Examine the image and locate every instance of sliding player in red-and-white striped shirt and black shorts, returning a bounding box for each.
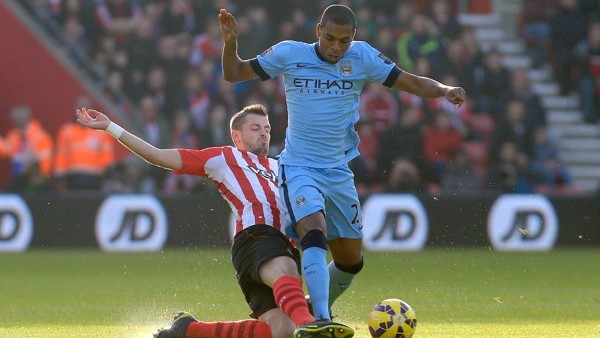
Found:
[76,104,354,338]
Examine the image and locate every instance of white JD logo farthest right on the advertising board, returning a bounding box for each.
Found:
[488,195,558,251]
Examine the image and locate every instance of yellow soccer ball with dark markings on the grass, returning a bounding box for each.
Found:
[369,299,417,338]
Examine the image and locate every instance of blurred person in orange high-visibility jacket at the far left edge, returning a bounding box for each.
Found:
[0,105,54,184]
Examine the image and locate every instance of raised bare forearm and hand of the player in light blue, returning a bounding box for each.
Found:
[219,9,258,82]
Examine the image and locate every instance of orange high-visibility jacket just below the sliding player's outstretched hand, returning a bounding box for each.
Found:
[54,123,115,176]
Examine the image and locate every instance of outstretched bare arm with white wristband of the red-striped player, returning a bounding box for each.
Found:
[75,108,183,169]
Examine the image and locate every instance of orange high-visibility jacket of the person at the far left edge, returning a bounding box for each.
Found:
[0,119,54,176]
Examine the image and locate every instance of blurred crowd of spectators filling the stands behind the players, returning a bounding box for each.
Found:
[0,0,600,196]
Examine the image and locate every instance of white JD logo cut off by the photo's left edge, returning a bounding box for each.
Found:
[0,195,33,251]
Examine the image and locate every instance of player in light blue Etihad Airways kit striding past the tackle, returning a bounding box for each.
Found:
[219,5,466,337]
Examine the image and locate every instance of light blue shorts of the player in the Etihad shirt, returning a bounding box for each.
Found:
[279,164,363,240]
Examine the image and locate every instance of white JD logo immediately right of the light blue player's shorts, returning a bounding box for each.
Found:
[363,194,429,251]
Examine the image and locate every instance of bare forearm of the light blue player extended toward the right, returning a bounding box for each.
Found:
[394,72,466,107]
